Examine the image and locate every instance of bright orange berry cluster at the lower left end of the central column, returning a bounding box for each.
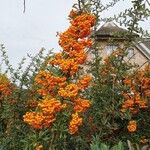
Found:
[23,98,66,129]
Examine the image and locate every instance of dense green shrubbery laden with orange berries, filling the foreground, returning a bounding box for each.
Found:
[0,0,150,150]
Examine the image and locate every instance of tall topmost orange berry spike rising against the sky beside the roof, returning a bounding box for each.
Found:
[49,10,95,76]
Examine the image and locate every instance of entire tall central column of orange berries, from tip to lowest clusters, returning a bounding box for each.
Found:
[24,10,95,134]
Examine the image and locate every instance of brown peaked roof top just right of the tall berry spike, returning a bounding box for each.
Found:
[95,21,138,39]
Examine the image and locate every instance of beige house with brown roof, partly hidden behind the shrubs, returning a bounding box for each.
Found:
[95,22,150,67]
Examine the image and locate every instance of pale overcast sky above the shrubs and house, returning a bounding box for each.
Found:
[0,0,149,67]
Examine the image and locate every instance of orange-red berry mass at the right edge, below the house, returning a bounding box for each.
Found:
[122,66,150,114]
